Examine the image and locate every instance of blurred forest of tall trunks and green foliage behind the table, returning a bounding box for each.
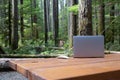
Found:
[0,0,120,55]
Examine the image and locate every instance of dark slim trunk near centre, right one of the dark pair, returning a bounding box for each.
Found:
[53,0,59,46]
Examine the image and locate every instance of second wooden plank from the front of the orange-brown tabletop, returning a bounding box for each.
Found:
[9,54,120,70]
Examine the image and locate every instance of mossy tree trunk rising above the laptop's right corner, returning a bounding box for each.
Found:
[98,0,105,36]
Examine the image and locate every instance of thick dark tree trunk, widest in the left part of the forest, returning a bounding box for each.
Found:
[11,0,18,50]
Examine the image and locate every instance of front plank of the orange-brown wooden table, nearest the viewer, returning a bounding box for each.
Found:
[29,61,120,80]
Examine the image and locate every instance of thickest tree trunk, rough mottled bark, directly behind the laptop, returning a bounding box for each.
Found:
[79,0,93,35]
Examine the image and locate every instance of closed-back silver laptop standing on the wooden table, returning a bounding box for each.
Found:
[73,36,104,57]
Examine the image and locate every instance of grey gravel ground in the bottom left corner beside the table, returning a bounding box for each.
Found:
[0,71,28,80]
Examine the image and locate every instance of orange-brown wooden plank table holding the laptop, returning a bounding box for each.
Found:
[8,54,120,80]
